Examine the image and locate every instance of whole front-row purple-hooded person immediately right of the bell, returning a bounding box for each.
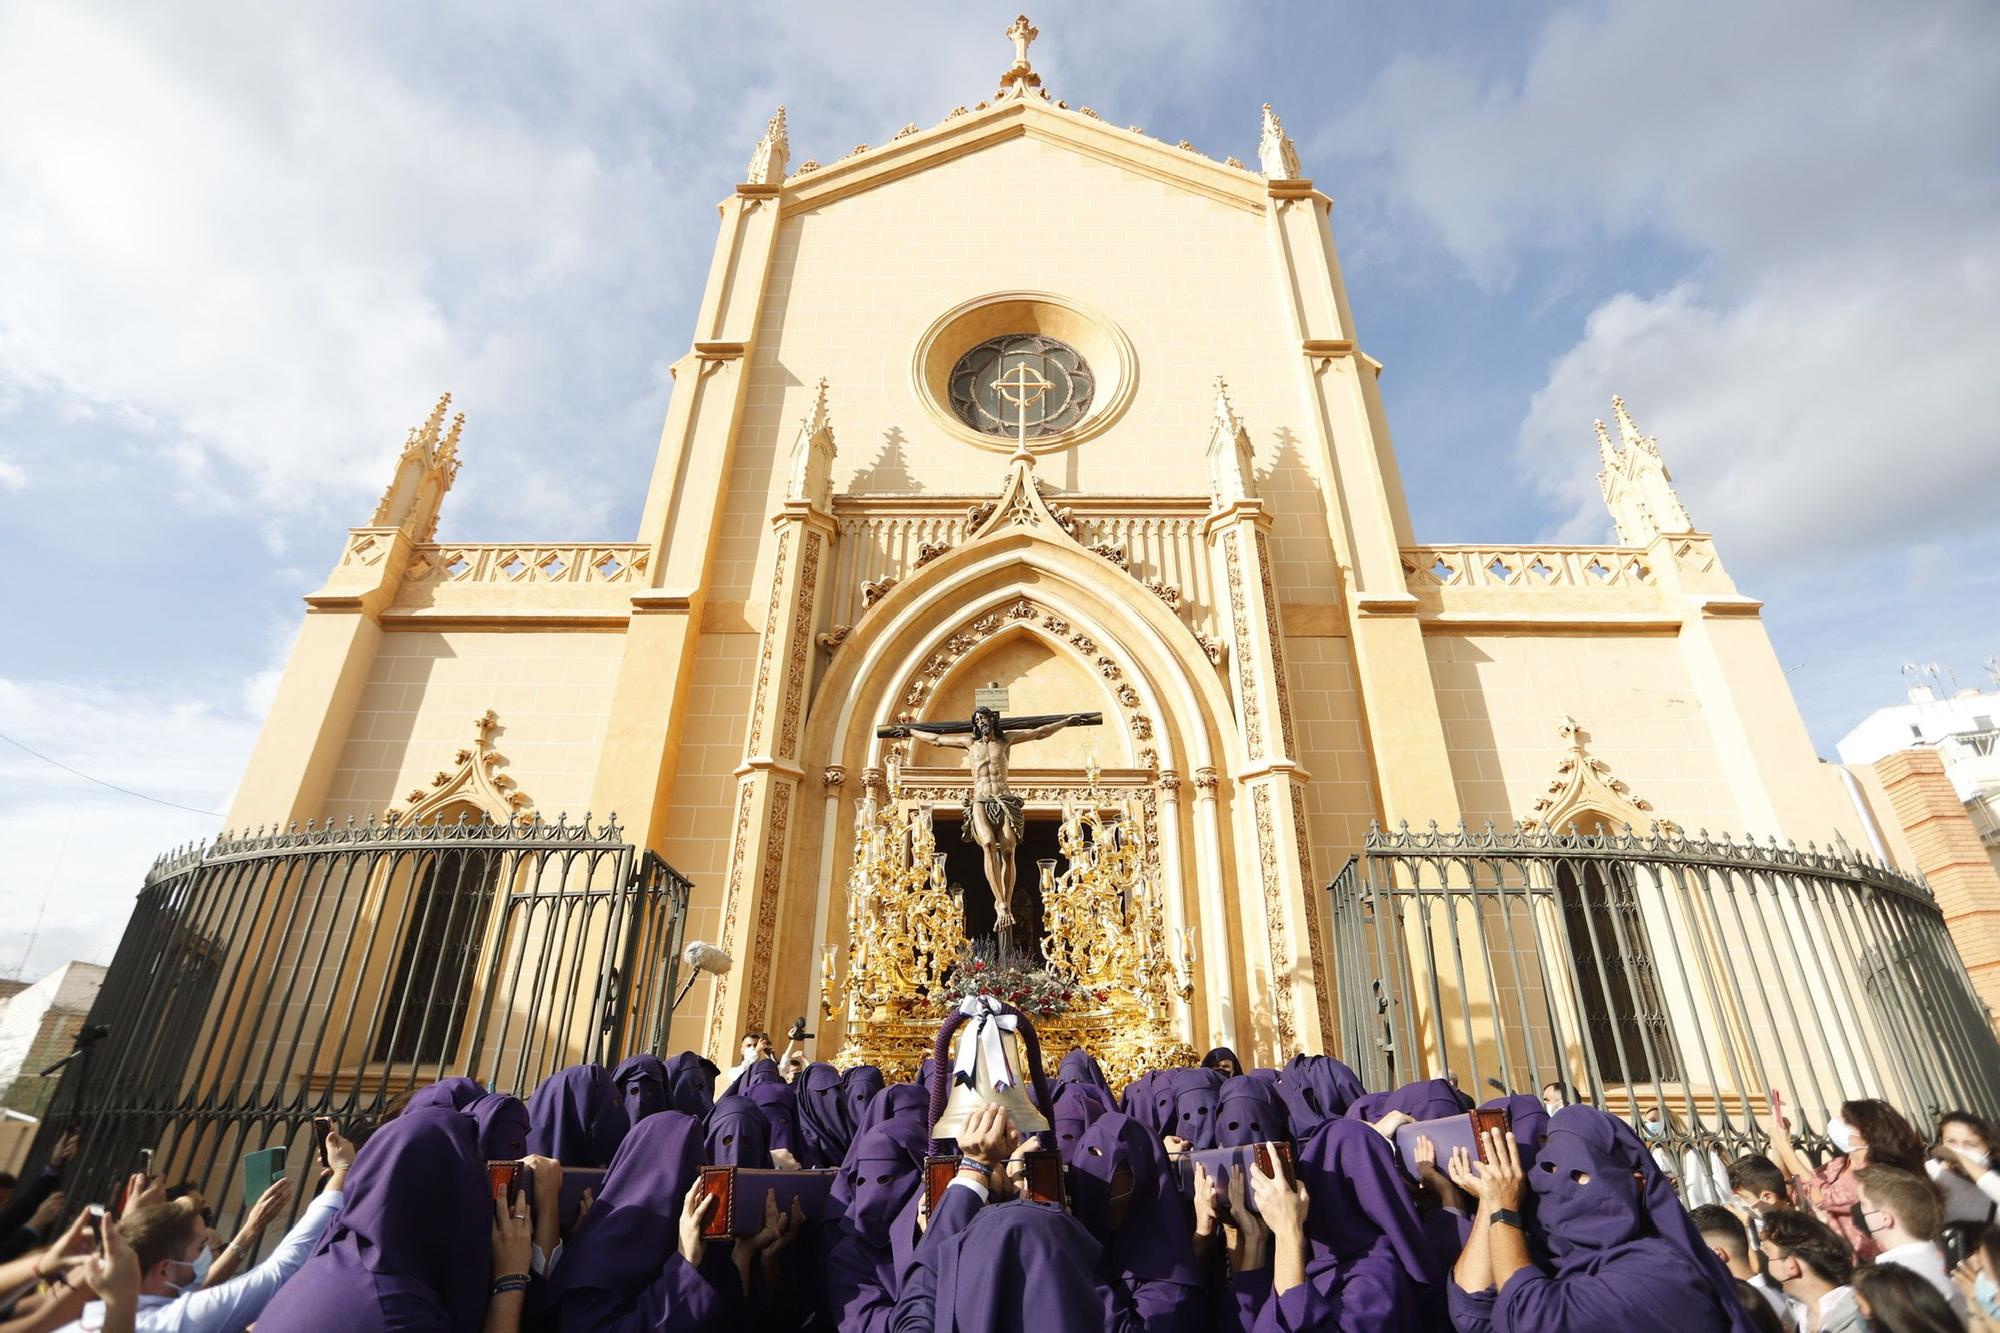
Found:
[1070,1113,1208,1333]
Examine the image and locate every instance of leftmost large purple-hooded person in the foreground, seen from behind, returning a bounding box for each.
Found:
[258,1107,492,1333]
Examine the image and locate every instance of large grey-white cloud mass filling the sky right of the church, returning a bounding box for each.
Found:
[1342,0,2000,572]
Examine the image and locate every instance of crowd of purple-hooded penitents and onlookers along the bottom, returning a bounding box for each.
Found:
[0,1016,2000,1333]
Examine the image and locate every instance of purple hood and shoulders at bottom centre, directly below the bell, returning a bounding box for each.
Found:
[894,1189,1142,1333]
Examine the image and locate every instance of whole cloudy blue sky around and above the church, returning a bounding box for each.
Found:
[0,0,2000,977]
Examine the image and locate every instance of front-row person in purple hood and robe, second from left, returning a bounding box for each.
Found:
[548,1111,744,1333]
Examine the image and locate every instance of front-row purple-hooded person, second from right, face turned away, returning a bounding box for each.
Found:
[1236,1119,1446,1333]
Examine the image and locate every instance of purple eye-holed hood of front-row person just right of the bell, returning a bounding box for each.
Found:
[1058,1105,1202,1289]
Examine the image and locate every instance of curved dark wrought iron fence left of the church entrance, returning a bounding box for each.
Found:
[30,821,690,1213]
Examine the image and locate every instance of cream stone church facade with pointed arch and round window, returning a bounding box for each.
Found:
[232,31,1896,1063]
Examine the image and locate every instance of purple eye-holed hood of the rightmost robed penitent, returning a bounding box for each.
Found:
[1528,1107,1752,1333]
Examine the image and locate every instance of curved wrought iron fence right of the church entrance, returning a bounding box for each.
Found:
[1330,829,2000,1157]
